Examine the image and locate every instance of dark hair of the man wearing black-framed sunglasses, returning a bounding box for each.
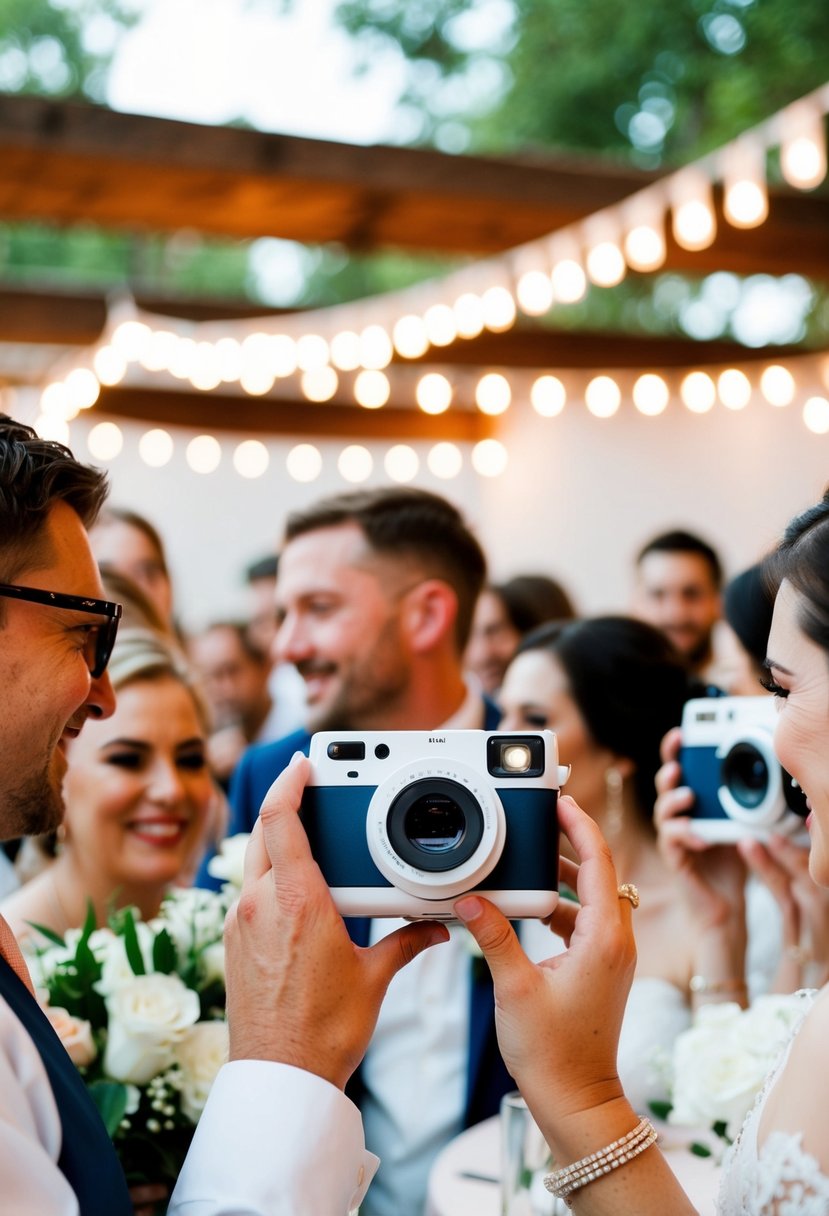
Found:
[0,413,108,582]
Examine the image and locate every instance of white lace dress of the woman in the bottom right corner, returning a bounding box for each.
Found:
[717,992,829,1216]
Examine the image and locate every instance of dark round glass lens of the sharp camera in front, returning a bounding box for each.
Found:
[387,777,484,873]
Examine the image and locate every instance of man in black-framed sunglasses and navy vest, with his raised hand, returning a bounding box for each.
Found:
[0,416,446,1216]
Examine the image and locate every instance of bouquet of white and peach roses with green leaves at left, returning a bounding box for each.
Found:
[29,844,249,1190]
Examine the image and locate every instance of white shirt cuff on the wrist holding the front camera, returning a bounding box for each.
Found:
[169,1060,379,1216]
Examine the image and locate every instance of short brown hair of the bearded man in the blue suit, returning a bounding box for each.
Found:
[284,486,486,651]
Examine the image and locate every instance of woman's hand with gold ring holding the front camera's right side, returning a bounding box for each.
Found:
[455,796,636,1132]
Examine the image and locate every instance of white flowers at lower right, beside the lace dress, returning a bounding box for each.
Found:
[654,992,810,1156]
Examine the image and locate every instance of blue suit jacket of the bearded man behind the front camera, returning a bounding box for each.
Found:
[198,699,515,1127]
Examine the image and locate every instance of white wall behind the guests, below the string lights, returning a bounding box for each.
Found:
[16,401,829,627]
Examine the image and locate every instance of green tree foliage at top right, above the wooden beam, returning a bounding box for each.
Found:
[337,0,829,168]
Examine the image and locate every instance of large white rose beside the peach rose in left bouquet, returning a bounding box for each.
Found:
[103,975,199,1085]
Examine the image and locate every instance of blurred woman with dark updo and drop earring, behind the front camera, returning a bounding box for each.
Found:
[500,617,707,1109]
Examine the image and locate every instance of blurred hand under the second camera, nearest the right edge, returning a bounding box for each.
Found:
[738,835,829,992]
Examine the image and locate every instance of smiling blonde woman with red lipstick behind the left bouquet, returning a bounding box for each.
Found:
[2,629,218,936]
